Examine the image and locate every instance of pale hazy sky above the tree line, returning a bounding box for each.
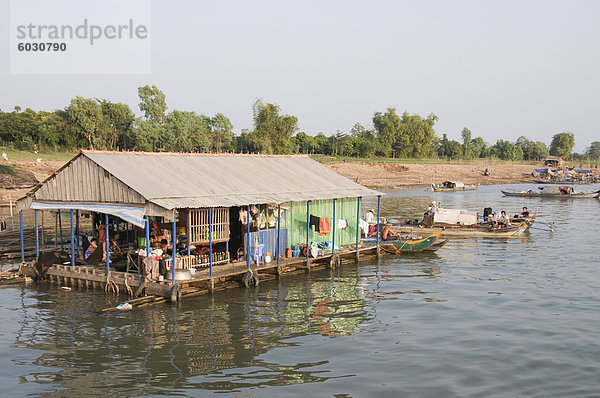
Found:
[0,0,600,152]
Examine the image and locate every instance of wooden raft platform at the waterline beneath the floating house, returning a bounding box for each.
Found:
[20,246,377,311]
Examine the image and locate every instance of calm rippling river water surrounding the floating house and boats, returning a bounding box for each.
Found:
[0,185,600,397]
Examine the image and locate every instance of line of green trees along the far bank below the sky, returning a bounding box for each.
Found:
[0,86,600,161]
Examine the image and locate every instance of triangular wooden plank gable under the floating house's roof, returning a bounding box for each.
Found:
[34,156,146,204]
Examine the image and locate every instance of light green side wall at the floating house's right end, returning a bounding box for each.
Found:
[287,198,357,246]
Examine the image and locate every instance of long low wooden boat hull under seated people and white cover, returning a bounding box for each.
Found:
[392,221,530,237]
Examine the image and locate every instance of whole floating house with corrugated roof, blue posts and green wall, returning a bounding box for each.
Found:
[17,150,381,304]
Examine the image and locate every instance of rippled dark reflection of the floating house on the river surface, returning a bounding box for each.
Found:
[7,268,366,395]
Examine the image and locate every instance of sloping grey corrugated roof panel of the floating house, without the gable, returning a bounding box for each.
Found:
[82,151,381,209]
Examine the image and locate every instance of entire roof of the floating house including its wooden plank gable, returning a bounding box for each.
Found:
[20,151,381,222]
